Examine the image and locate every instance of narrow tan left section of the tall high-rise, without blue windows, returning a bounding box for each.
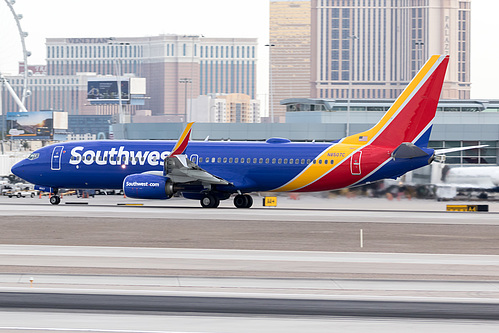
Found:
[269,0,311,122]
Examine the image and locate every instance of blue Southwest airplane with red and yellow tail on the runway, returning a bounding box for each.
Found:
[12,55,484,208]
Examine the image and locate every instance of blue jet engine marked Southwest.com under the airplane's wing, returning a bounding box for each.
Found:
[123,173,175,199]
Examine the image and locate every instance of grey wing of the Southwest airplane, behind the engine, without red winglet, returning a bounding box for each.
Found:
[164,155,230,185]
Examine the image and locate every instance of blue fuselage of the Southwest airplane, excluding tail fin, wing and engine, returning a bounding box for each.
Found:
[12,140,433,193]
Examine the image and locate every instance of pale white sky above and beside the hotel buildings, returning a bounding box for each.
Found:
[0,0,499,105]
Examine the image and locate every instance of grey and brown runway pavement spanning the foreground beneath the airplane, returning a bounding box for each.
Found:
[0,197,499,332]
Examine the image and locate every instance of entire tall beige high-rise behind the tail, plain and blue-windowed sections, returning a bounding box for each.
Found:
[270,0,471,122]
